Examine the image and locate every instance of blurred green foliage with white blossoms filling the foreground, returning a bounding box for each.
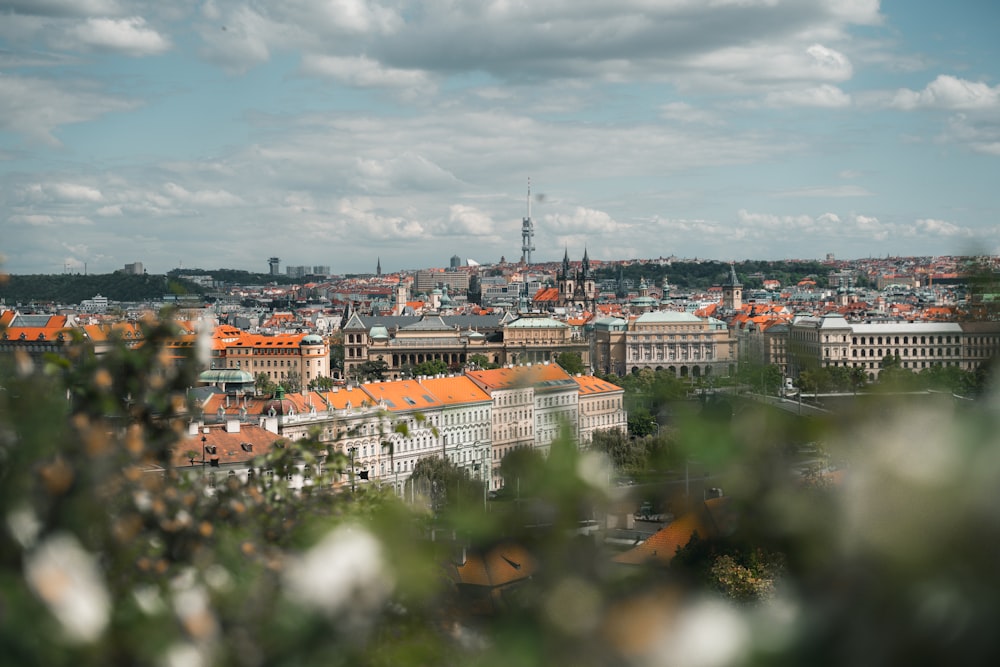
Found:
[0,314,1000,667]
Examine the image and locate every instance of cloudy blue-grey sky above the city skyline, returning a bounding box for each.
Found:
[0,0,1000,274]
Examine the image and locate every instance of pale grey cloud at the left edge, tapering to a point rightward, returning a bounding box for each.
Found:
[0,73,138,145]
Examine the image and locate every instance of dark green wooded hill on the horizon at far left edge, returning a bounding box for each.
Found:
[0,273,204,306]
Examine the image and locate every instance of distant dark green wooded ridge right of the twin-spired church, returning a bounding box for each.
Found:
[595,260,867,289]
